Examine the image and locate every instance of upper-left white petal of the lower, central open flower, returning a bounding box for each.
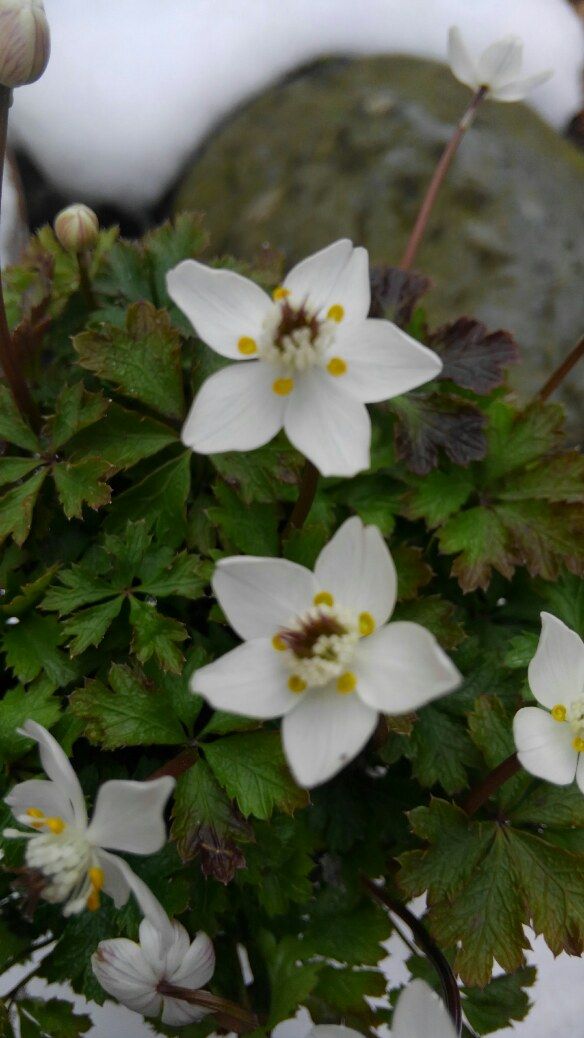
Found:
[213,555,316,638]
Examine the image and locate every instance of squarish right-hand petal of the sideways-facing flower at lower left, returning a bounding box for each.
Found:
[87,775,174,854]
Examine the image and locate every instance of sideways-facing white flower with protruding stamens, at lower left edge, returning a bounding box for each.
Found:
[4,720,174,916]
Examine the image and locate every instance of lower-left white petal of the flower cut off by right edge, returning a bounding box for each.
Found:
[513,707,578,786]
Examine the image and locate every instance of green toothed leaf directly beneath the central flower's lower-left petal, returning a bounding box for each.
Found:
[204,732,308,819]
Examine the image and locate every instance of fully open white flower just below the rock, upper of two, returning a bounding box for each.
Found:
[167,240,442,476]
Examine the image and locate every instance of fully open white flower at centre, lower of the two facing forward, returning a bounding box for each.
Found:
[191,517,460,787]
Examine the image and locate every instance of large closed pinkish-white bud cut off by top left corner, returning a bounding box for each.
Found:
[0,0,51,88]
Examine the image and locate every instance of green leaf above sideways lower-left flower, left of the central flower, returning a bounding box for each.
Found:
[69,663,185,749]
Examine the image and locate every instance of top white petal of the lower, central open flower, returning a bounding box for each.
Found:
[314,516,397,627]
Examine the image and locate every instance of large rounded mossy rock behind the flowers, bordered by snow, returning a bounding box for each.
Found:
[175,57,584,421]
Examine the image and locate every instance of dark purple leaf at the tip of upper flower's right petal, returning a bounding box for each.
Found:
[427,318,519,393]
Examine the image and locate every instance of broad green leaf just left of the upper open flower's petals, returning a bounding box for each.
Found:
[74,302,185,418]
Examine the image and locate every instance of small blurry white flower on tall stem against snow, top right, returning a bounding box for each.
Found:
[448,26,553,101]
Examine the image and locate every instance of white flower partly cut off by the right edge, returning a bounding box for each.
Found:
[513,612,584,793]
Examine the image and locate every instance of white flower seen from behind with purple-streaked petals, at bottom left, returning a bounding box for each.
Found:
[91,889,215,1028]
